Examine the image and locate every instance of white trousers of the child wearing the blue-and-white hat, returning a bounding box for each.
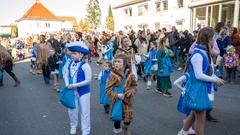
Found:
[68,93,91,135]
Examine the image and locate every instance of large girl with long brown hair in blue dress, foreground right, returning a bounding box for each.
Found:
[178,27,224,135]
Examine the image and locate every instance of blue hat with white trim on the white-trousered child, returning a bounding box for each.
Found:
[66,41,90,55]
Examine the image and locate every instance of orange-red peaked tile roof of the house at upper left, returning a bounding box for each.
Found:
[17,0,60,21]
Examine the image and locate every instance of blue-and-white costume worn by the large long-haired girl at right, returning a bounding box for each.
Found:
[183,45,217,111]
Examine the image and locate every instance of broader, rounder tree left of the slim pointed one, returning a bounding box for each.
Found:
[86,0,101,30]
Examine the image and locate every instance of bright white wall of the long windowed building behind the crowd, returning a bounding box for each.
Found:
[113,0,190,31]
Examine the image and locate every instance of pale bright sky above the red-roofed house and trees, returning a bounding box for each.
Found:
[0,0,127,25]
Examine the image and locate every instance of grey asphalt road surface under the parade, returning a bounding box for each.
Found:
[0,59,240,135]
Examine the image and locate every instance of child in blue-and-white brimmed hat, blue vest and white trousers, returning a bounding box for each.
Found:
[64,41,92,135]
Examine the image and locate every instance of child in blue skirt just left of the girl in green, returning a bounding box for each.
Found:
[144,41,158,90]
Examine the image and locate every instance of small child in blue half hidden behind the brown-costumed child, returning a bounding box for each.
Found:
[98,62,112,114]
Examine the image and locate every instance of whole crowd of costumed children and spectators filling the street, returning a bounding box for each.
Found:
[0,22,240,135]
